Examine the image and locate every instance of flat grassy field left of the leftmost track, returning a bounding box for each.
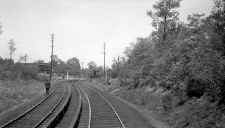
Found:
[0,80,44,113]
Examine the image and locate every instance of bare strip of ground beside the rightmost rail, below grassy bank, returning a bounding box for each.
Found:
[91,87,155,128]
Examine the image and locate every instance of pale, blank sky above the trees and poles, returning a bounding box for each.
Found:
[0,0,213,66]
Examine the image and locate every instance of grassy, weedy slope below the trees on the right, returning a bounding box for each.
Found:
[90,78,225,128]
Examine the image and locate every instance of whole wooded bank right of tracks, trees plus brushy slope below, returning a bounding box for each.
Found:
[111,0,225,128]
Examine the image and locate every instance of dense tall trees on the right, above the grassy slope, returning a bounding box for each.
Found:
[111,0,225,103]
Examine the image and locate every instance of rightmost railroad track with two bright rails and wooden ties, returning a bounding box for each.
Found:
[80,86,125,128]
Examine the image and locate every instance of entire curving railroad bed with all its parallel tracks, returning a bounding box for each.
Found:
[0,82,154,128]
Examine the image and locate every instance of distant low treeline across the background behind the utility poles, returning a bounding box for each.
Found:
[0,36,104,80]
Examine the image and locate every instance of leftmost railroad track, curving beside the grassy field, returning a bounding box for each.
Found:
[1,86,68,128]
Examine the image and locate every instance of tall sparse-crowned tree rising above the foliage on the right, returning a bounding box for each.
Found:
[147,0,181,40]
